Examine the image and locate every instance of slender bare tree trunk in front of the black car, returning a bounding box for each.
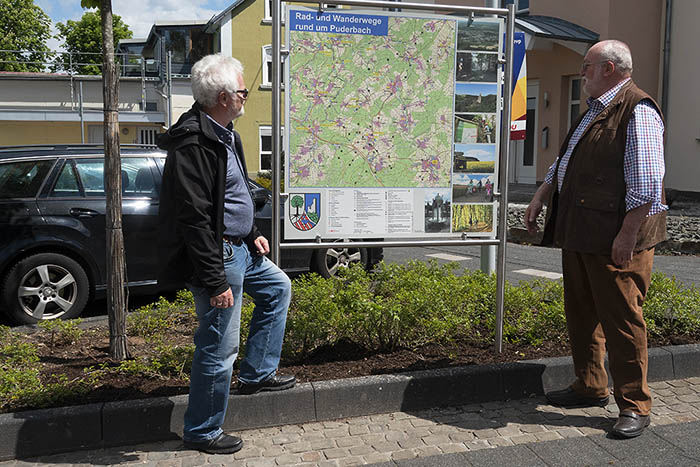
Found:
[100,0,129,361]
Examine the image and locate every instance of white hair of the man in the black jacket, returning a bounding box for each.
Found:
[191,54,243,107]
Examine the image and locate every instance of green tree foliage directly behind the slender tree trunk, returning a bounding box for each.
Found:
[55,10,133,75]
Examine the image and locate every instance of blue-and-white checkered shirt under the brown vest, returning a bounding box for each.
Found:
[544,78,668,216]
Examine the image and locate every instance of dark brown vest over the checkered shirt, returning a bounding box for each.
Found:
[542,80,666,256]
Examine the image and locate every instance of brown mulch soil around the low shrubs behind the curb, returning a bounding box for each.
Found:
[6,326,694,412]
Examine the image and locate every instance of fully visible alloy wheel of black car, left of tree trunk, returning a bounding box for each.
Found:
[2,253,90,324]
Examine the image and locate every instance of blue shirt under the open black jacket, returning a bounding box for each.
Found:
[207,115,255,237]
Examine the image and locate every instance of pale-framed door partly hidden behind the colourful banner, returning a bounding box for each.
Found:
[508,82,540,184]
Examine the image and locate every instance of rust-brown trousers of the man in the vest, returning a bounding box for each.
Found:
[562,248,654,415]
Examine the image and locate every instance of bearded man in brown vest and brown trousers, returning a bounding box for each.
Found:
[525,40,667,438]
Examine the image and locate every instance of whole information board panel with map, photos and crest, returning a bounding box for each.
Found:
[284,7,503,239]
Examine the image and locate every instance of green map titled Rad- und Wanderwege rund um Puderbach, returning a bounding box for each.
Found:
[287,9,457,188]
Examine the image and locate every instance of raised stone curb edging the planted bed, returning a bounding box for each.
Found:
[0,344,700,460]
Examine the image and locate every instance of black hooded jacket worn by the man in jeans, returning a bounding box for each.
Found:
[158,103,260,297]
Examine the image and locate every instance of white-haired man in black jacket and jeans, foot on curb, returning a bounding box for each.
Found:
[158,54,296,454]
